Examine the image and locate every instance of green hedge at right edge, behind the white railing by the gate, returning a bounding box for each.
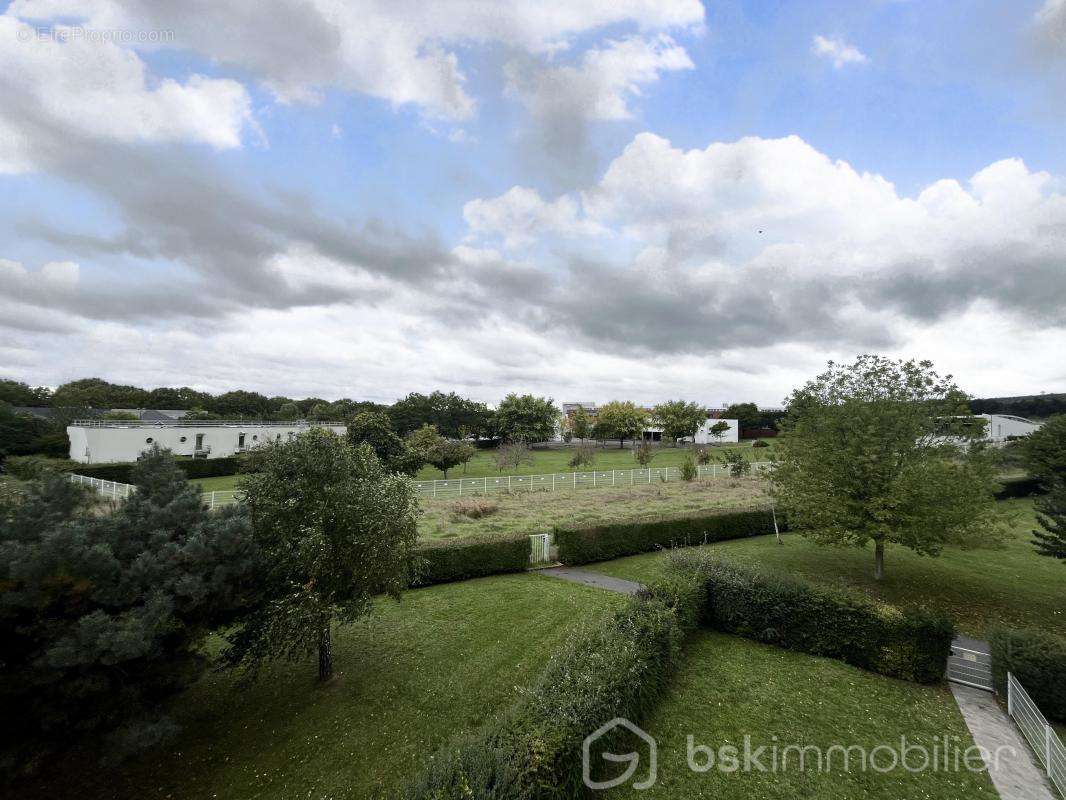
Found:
[988,628,1066,722]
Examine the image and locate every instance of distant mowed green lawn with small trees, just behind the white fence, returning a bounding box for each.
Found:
[194,439,773,492]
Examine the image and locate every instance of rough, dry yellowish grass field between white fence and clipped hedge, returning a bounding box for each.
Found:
[418,478,765,539]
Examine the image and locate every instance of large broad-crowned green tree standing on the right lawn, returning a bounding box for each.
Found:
[776,355,1002,580]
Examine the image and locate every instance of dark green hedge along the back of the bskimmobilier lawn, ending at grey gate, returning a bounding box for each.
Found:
[671,551,955,684]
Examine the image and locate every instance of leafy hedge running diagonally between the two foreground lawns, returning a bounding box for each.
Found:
[403,596,683,800]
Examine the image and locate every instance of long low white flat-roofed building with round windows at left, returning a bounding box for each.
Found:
[67,419,348,464]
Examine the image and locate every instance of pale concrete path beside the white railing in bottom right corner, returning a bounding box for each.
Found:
[949,684,1056,800]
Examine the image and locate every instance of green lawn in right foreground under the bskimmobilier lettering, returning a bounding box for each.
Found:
[607,633,998,800]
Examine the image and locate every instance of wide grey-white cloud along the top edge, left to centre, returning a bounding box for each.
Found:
[9,0,704,119]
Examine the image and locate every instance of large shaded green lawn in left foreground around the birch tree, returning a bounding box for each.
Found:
[13,574,623,800]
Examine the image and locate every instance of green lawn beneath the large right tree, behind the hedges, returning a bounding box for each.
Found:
[589,499,1066,637]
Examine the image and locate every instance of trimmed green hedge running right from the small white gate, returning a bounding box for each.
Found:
[554,509,781,564]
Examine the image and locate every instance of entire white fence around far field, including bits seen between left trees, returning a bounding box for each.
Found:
[69,461,773,509]
